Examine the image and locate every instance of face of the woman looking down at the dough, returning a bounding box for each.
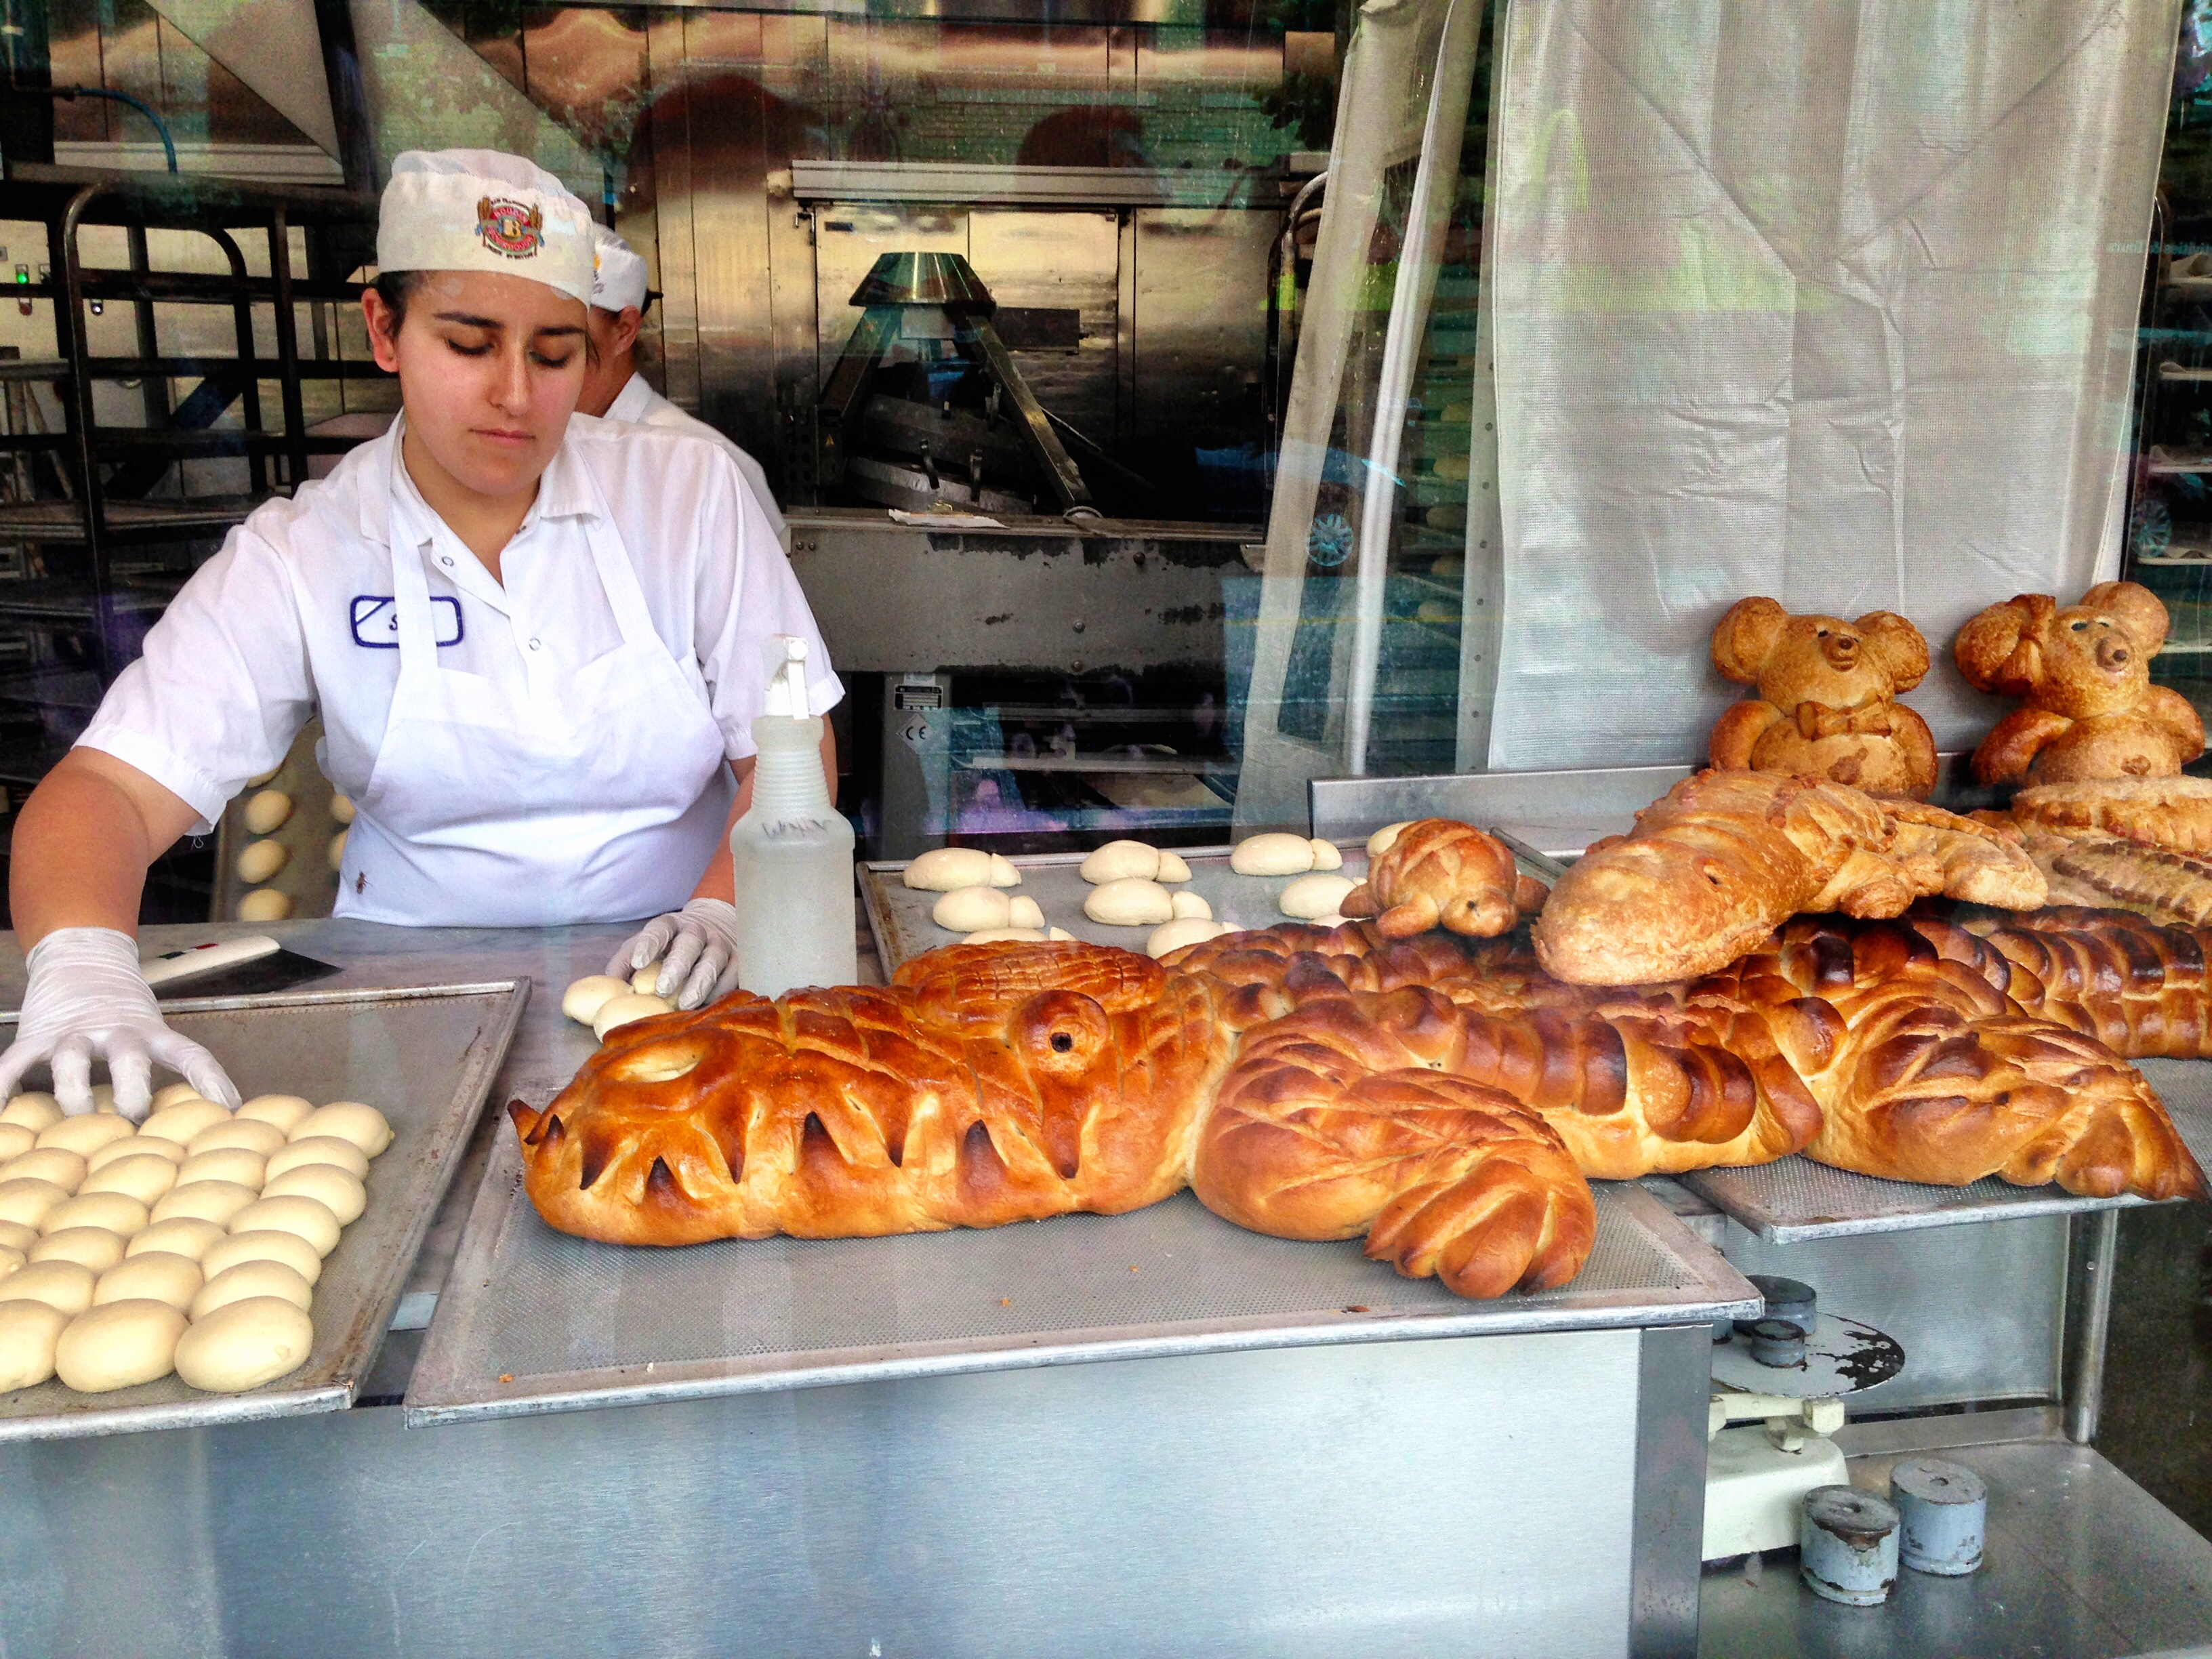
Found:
[361,270,584,495]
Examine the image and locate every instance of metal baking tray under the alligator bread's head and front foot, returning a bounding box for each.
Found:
[405,1132,1761,1427]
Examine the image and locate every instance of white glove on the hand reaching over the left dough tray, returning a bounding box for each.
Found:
[0,927,239,1124]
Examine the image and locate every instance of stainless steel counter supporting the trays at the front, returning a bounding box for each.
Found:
[0,922,1725,1659]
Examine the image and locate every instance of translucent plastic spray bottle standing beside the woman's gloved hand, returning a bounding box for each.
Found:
[730,635,858,998]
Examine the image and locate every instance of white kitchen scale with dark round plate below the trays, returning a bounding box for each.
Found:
[1703,1274,1904,1561]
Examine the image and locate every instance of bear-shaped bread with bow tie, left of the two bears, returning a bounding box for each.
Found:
[1708,600,1936,801]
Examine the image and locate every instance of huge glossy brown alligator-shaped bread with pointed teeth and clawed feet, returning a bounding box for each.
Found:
[509,912,2212,1296]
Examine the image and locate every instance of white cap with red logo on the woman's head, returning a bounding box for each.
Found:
[376,150,595,305]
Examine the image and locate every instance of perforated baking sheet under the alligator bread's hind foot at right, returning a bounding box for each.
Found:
[1679,1059,2212,1243]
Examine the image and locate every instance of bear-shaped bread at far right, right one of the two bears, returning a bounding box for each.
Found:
[1953,581,2205,783]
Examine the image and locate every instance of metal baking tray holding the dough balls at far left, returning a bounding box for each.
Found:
[0,980,529,1442]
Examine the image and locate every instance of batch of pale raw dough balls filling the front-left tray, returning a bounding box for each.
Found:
[0,1084,392,1393]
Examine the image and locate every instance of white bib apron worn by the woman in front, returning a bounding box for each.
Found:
[334,445,737,927]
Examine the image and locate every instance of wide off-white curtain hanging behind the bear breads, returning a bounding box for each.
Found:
[1486,0,2177,770]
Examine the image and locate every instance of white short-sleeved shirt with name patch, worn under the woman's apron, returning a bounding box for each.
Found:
[80,416,843,922]
